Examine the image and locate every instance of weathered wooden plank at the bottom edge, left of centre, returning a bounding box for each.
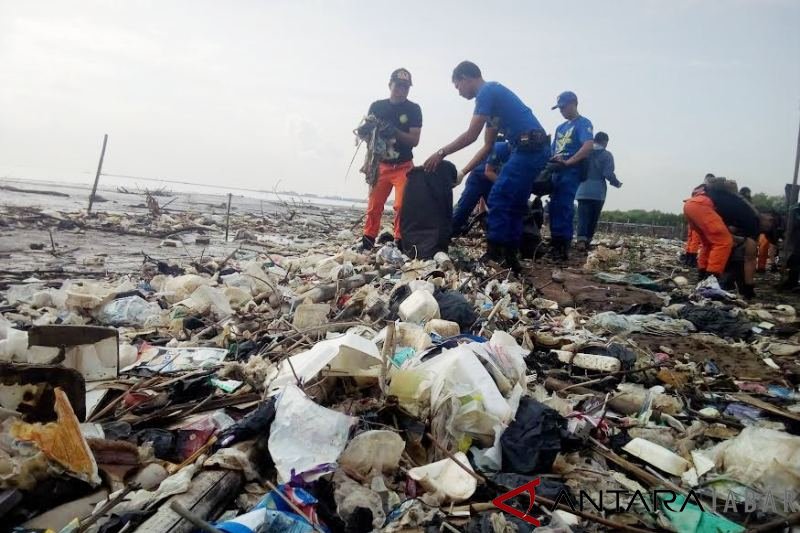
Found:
[136,470,244,533]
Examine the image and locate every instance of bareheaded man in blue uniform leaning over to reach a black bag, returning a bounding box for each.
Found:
[425,61,552,272]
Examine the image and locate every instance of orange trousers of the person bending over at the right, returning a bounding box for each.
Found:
[683,194,733,276]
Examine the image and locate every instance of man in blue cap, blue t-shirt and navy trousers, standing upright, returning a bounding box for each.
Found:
[550,91,594,261]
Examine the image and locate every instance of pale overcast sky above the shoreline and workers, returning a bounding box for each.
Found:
[0,0,800,211]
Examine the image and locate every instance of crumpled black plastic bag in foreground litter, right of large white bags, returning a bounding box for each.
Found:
[500,397,567,474]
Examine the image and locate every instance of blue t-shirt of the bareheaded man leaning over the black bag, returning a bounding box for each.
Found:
[473,81,544,142]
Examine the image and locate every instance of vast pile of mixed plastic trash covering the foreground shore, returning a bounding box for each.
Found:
[0,205,800,533]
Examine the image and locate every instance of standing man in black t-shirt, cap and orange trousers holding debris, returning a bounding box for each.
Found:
[361,68,422,250]
